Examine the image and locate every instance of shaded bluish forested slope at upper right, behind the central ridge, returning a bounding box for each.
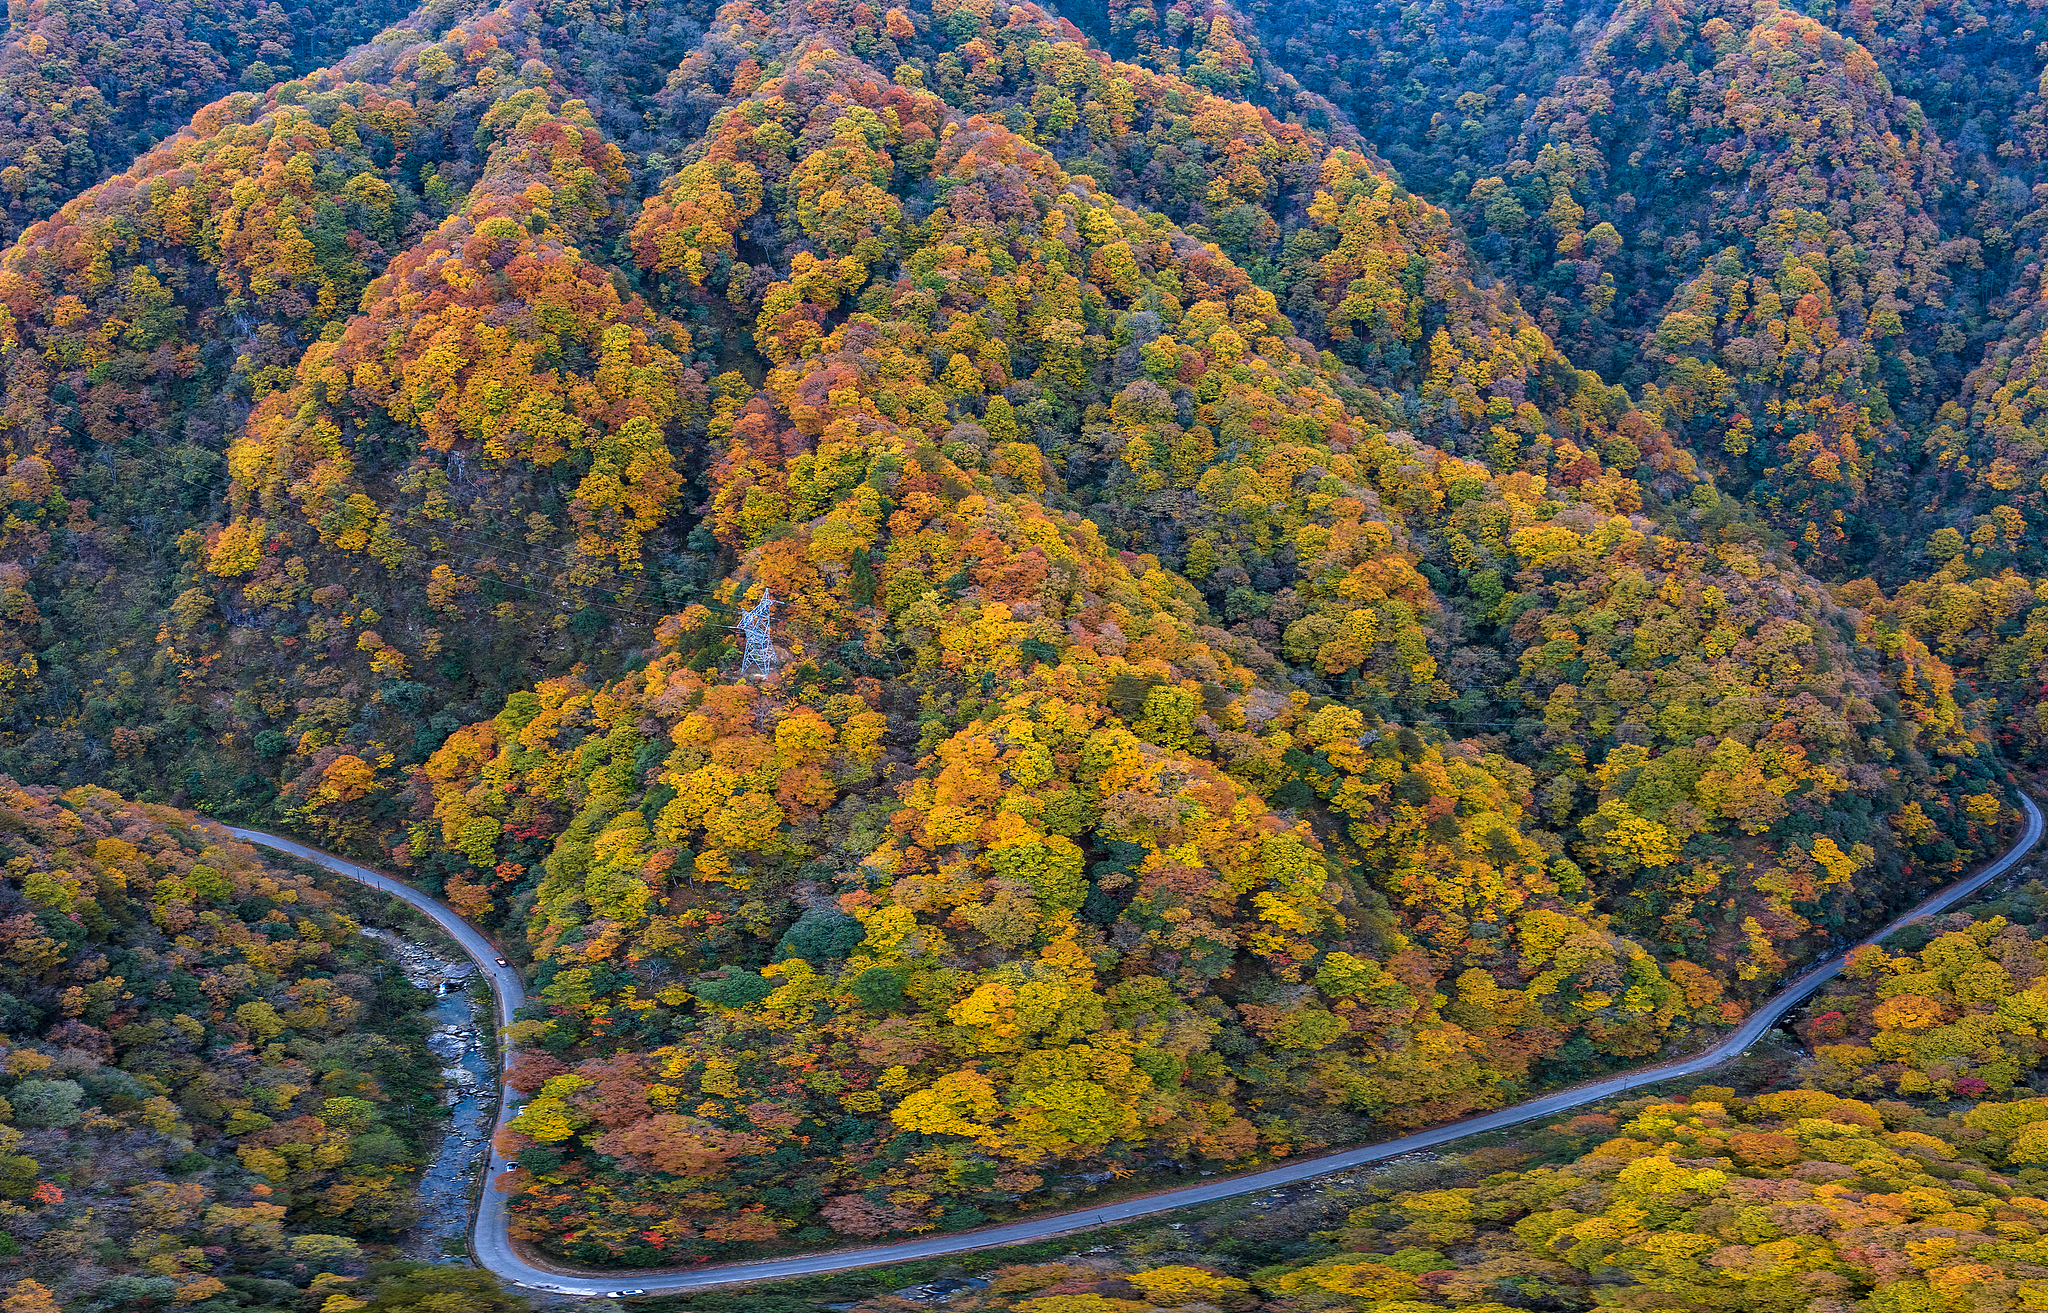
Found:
[1228,4,2042,574]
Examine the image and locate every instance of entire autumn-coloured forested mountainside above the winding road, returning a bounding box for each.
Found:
[0,0,2048,1313]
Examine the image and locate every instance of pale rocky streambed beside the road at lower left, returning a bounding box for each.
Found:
[362,928,498,1260]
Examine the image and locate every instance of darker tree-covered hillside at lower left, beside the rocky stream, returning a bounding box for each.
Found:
[0,778,450,1309]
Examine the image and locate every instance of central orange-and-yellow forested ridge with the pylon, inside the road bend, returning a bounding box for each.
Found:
[235,8,2003,1262]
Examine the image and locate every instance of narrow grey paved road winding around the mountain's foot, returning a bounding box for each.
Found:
[221,795,2042,1295]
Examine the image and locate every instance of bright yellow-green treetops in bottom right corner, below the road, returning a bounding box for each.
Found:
[917,1088,2044,1313]
